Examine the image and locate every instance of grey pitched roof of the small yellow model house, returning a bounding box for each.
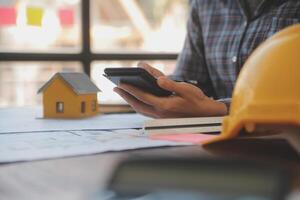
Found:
[38,72,101,95]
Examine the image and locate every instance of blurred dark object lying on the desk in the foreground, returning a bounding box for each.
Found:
[108,158,290,200]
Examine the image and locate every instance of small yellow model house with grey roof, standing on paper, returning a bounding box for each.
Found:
[38,73,100,118]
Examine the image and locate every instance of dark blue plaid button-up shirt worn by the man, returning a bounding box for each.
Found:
[172,0,300,103]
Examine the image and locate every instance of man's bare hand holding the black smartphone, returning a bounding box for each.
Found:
[114,63,227,118]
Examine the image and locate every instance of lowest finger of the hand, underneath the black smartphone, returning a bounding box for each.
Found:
[114,87,157,117]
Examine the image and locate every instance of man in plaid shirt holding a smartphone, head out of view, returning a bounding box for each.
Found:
[115,0,300,118]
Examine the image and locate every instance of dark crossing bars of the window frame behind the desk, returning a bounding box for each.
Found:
[0,0,178,76]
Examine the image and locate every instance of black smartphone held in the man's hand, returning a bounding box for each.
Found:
[103,68,172,96]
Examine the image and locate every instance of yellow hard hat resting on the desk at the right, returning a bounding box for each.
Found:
[206,24,300,143]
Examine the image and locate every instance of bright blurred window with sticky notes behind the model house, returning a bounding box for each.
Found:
[0,0,189,107]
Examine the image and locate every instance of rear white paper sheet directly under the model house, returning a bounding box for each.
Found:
[0,107,149,134]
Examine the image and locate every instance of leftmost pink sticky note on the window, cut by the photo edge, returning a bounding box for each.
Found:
[0,7,17,26]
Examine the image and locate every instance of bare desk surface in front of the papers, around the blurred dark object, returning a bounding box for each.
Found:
[0,139,300,200]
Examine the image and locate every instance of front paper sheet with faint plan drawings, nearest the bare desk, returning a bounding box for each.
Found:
[0,129,191,163]
